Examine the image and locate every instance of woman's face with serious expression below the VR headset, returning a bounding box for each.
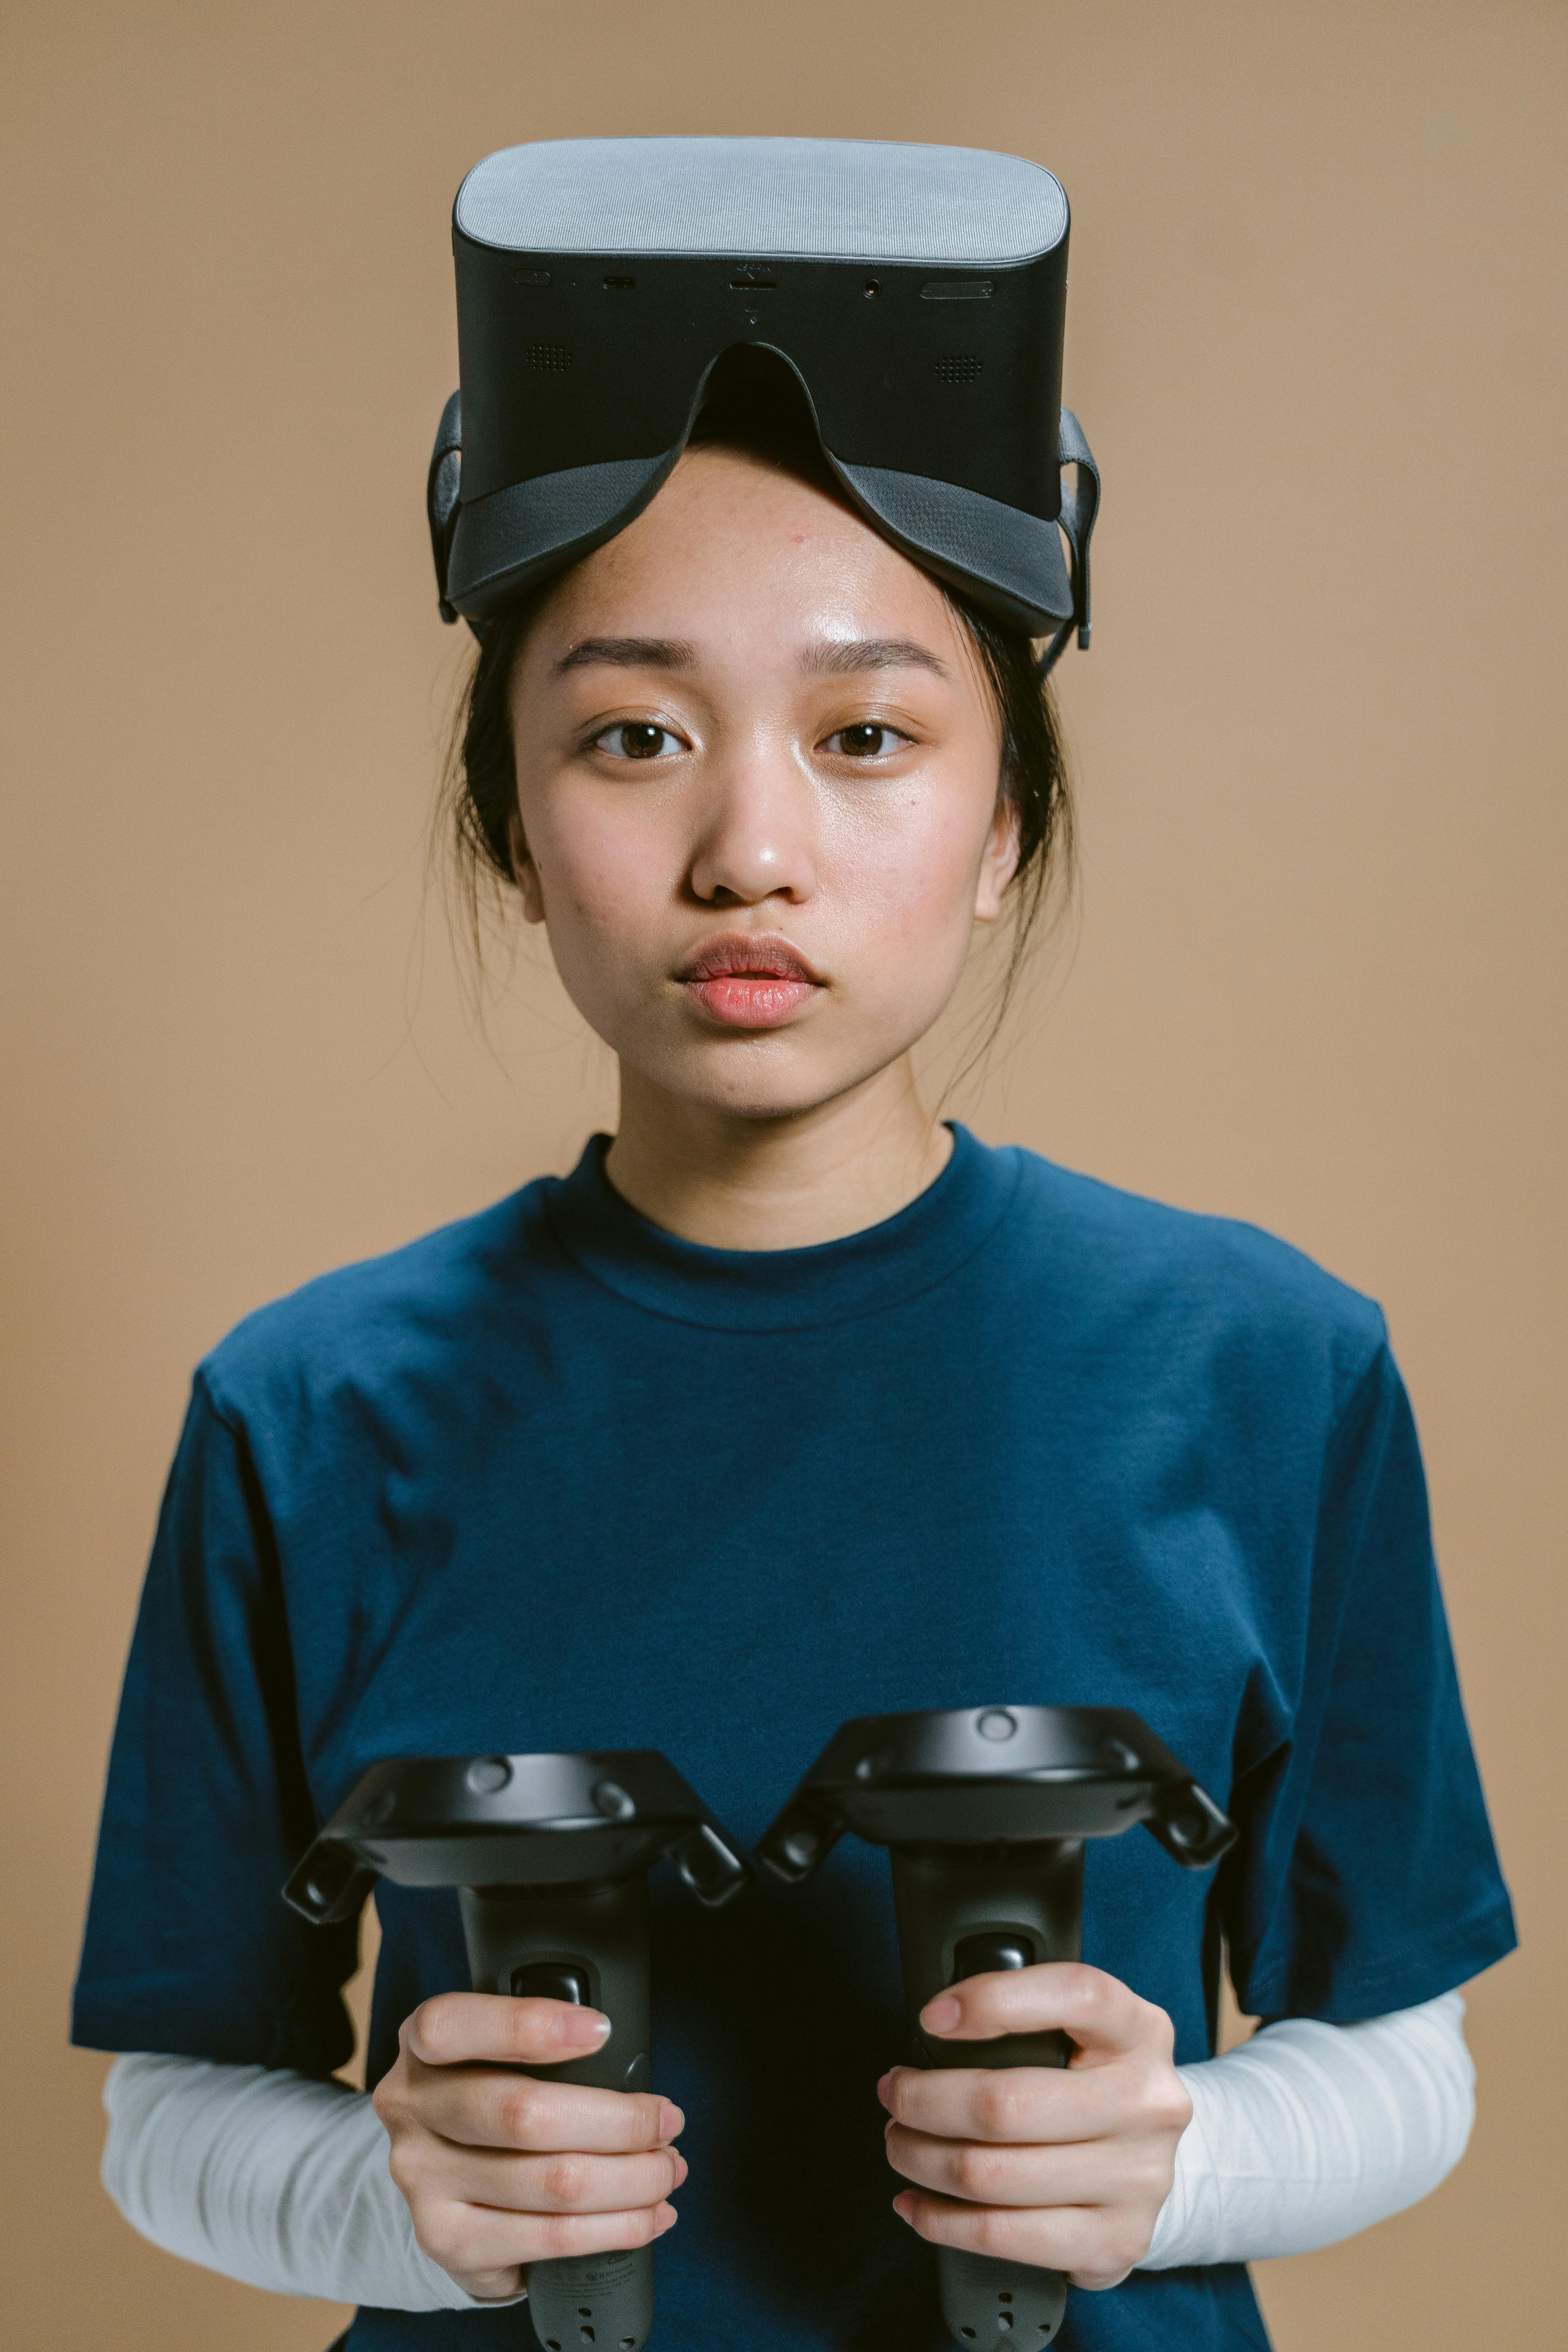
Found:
[512,449,1016,1117]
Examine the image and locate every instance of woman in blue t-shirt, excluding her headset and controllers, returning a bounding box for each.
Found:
[75,258,1512,2352]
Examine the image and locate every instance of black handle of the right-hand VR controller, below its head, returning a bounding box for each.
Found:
[891,1839,1084,2352]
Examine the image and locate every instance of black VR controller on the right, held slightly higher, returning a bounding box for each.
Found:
[757,1708,1236,2352]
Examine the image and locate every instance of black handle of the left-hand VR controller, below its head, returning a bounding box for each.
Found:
[458,1872,653,2352]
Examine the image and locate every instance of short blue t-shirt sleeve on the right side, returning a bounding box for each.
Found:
[1218,1345,1514,2023]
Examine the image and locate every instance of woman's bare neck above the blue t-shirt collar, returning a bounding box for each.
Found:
[604,1058,952,1249]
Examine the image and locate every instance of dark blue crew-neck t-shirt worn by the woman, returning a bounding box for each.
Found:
[75,1129,1514,2352]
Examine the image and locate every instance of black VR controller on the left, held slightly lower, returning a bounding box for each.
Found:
[285,1748,750,2352]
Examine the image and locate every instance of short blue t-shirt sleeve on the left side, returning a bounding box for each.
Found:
[71,1374,358,2074]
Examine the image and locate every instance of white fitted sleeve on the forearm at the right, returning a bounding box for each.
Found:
[1138,1992,1476,2270]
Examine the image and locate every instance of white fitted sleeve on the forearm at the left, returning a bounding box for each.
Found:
[103,2056,522,2312]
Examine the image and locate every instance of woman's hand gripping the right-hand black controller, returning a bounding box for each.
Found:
[877,1964,1192,2288]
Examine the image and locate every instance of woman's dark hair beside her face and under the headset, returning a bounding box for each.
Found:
[444,350,1074,1042]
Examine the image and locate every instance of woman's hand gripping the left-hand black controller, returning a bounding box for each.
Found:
[374,1992,686,2300]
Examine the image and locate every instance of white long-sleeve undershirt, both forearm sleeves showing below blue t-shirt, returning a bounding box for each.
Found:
[103,1992,1474,2312]
